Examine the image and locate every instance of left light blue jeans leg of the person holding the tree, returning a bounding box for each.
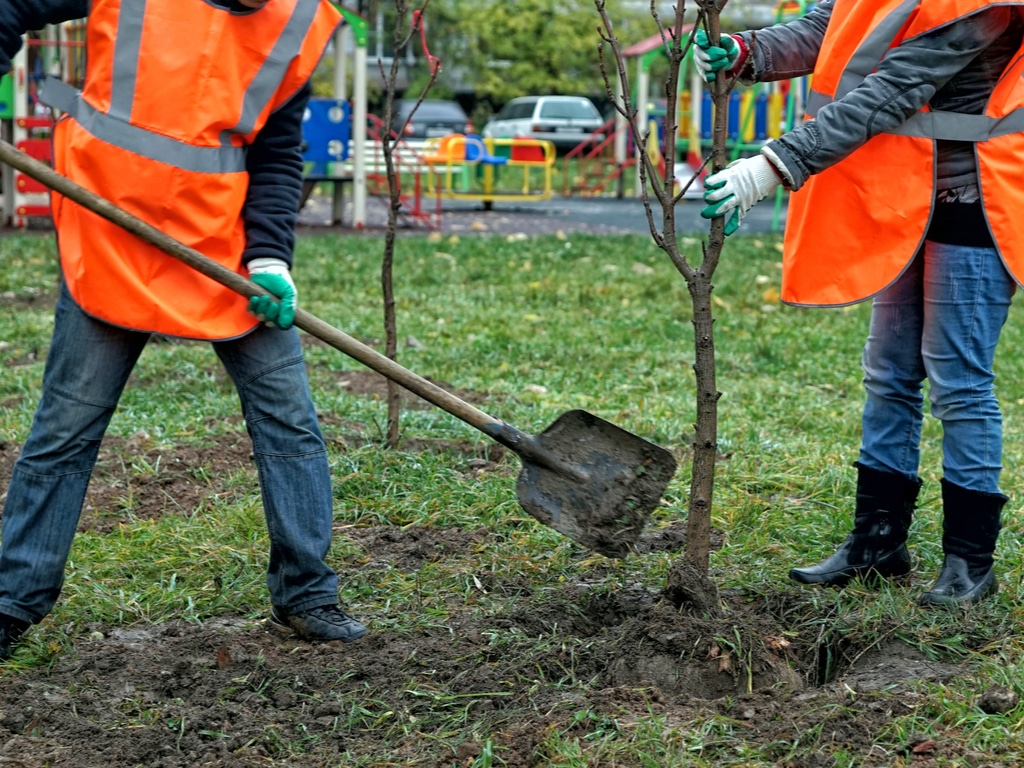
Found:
[858,253,925,480]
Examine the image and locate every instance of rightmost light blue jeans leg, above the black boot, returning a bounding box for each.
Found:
[922,243,1016,494]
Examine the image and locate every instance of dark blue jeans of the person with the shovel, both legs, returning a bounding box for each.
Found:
[0,287,338,622]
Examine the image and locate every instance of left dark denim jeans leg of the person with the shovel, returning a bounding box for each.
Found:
[0,287,148,622]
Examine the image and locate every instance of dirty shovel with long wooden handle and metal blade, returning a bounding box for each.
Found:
[0,140,676,557]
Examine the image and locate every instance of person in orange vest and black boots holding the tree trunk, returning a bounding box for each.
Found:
[694,0,1024,605]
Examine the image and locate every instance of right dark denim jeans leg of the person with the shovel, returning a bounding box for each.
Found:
[214,326,338,611]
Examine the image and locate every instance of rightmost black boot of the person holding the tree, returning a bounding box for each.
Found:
[918,479,1007,605]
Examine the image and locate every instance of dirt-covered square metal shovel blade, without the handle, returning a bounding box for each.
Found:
[516,411,676,557]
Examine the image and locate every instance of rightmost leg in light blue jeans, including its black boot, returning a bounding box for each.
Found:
[920,243,1016,604]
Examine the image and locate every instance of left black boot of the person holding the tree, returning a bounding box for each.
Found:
[790,464,921,587]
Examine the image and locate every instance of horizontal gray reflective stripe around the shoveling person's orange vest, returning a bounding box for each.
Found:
[39,77,246,173]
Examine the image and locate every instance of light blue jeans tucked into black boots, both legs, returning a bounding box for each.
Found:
[859,242,1016,494]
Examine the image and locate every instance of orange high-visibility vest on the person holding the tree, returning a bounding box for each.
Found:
[782,0,1024,306]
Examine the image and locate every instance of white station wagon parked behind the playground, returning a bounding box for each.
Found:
[483,96,605,150]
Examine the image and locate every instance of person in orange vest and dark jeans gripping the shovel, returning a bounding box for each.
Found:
[0,0,367,660]
